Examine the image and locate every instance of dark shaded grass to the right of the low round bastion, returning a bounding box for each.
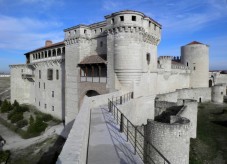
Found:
[190,103,227,164]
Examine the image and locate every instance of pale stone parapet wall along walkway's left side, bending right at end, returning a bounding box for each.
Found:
[56,91,122,164]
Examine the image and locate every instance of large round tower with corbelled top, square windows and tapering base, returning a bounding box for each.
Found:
[105,10,161,87]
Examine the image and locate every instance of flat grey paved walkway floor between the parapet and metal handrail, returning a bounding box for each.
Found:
[88,105,143,164]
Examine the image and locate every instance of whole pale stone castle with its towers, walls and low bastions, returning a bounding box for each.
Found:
[10,10,227,163]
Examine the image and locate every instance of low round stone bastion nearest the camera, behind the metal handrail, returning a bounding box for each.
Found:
[144,116,190,164]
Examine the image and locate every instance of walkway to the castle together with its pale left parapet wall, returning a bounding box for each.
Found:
[56,91,143,164]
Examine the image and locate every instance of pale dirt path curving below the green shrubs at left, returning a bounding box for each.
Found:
[0,124,64,150]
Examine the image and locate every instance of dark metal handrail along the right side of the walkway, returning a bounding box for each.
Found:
[108,92,170,164]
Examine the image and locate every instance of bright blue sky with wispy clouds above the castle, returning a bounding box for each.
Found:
[0,0,227,72]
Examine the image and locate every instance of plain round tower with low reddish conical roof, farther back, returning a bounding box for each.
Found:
[181,41,209,88]
